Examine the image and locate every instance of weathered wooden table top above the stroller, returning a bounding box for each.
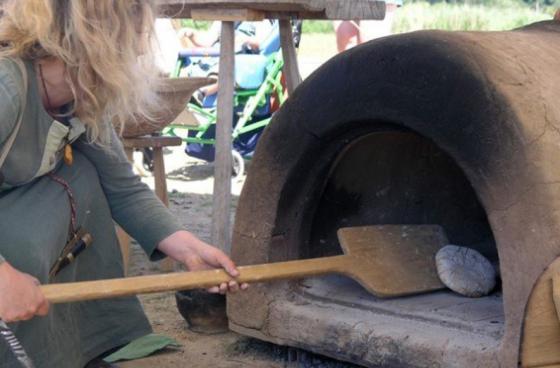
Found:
[158,0,385,19]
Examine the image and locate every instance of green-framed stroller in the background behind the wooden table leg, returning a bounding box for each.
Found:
[164,20,301,177]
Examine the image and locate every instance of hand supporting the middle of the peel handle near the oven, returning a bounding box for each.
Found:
[158,231,249,294]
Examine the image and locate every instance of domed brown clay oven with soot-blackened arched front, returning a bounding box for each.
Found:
[228,22,560,367]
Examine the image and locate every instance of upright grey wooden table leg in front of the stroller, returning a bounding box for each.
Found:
[212,21,235,254]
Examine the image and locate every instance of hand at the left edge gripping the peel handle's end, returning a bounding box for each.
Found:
[0,262,49,322]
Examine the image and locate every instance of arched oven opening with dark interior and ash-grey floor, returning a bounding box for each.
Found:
[293,130,504,346]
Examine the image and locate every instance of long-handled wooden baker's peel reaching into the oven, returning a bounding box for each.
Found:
[41,225,447,303]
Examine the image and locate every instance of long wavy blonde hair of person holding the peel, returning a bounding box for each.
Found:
[0,0,163,143]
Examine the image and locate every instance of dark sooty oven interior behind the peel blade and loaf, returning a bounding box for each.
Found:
[270,122,499,263]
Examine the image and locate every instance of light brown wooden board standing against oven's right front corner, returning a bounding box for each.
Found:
[521,258,560,368]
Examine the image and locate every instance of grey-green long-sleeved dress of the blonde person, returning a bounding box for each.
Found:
[0,59,181,368]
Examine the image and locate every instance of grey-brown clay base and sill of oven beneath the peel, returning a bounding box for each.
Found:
[230,276,504,368]
